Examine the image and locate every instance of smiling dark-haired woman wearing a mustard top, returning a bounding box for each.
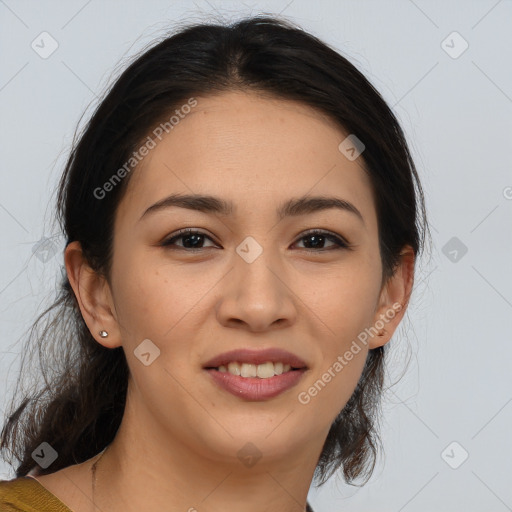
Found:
[0,17,428,512]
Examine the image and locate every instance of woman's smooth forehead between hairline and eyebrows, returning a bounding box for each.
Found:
[119,92,376,230]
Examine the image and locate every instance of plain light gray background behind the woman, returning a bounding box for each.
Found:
[0,0,512,512]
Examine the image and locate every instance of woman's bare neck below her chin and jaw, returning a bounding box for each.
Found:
[94,382,325,512]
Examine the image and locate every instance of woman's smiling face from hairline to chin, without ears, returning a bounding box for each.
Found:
[101,92,396,468]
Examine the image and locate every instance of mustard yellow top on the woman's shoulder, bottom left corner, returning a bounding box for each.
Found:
[0,476,72,512]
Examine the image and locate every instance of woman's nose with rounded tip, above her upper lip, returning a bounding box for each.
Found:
[216,251,298,332]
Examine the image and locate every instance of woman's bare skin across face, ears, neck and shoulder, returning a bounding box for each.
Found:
[38,92,414,512]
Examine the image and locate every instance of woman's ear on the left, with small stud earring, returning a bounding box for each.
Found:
[64,241,121,348]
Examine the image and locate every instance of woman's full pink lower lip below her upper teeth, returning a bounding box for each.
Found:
[206,368,306,401]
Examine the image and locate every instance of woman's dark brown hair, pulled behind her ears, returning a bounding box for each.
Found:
[0,16,428,485]
